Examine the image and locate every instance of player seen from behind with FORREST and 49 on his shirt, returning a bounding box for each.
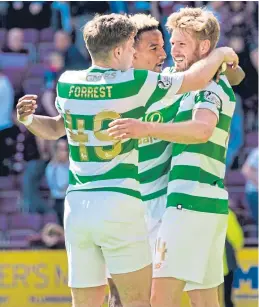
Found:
[17,14,238,307]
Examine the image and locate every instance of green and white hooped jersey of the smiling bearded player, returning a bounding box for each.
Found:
[167,76,236,214]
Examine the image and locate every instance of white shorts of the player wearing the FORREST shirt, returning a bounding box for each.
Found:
[64,191,152,288]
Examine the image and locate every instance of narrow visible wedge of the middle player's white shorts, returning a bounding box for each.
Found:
[144,195,167,254]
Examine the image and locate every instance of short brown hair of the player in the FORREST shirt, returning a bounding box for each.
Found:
[83,14,137,59]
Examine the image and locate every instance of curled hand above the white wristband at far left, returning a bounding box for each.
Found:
[16,95,38,122]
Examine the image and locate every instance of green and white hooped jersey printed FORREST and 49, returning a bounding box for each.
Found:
[56,66,183,198]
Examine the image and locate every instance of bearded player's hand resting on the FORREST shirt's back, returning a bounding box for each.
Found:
[107,118,150,140]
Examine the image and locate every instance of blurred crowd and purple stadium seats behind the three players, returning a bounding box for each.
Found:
[0,1,258,249]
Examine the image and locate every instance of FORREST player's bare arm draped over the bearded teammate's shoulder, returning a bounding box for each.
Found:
[177,47,238,94]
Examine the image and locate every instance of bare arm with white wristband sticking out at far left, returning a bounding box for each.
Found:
[16,95,66,140]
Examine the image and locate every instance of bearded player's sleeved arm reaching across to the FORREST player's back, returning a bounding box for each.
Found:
[108,82,222,144]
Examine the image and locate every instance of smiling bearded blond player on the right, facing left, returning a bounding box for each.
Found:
[108,8,243,307]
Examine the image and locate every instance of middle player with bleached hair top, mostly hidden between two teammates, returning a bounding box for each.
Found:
[131,14,244,255]
